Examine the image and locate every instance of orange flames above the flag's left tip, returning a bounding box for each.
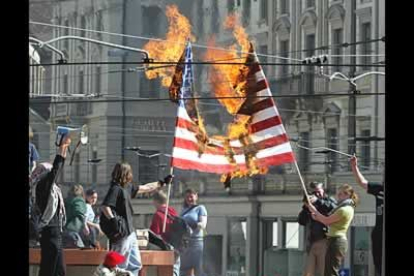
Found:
[144,5,195,87]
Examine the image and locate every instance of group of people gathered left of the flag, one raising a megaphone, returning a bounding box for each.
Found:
[29,134,207,276]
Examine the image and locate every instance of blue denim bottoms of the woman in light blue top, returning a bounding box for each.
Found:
[180,239,204,276]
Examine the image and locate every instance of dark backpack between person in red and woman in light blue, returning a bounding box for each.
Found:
[166,205,197,250]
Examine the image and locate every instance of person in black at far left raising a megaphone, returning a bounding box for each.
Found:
[32,137,71,276]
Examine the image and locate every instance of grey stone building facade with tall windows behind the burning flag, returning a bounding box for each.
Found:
[41,0,385,276]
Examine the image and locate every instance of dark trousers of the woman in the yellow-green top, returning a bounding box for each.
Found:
[324,237,348,276]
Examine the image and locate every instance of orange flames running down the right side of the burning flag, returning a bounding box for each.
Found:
[204,14,268,185]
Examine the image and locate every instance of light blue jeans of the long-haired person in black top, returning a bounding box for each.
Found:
[111,232,142,276]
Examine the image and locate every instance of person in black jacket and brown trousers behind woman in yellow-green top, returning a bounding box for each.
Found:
[298,182,336,276]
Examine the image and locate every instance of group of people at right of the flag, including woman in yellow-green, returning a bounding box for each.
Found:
[298,156,384,276]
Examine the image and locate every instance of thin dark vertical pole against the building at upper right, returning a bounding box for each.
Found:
[348,0,357,164]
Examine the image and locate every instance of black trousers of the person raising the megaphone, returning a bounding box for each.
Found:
[39,227,66,276]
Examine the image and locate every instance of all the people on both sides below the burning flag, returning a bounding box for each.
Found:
[29,129,384,276]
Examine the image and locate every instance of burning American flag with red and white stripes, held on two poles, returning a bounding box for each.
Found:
[170,43,295,178]
